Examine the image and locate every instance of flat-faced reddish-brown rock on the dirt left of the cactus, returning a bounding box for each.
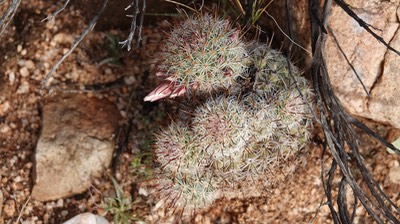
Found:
[32,94,120,201]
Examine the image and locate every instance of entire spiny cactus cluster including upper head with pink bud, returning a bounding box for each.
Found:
[147,15,312,214]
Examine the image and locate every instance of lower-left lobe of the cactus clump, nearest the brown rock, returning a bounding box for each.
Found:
[156,123,218,209]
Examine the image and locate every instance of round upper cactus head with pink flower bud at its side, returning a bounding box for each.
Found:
[144,14,247,101]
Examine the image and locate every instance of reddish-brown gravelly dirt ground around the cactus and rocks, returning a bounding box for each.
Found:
[0,0,400,223]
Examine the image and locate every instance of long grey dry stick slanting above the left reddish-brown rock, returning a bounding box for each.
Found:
[42,0,108,89]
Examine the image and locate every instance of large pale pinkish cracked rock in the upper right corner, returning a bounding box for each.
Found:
[325,0,400,128]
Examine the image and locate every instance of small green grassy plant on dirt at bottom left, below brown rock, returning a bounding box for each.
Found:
[101,178,140,224]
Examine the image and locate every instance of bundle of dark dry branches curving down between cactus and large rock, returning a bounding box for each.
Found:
[309,0,399,223]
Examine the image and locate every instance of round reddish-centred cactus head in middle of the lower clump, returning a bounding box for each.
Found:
[192,95,251,161]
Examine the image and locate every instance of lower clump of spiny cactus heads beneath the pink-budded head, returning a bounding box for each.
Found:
[156,92,310,210]
